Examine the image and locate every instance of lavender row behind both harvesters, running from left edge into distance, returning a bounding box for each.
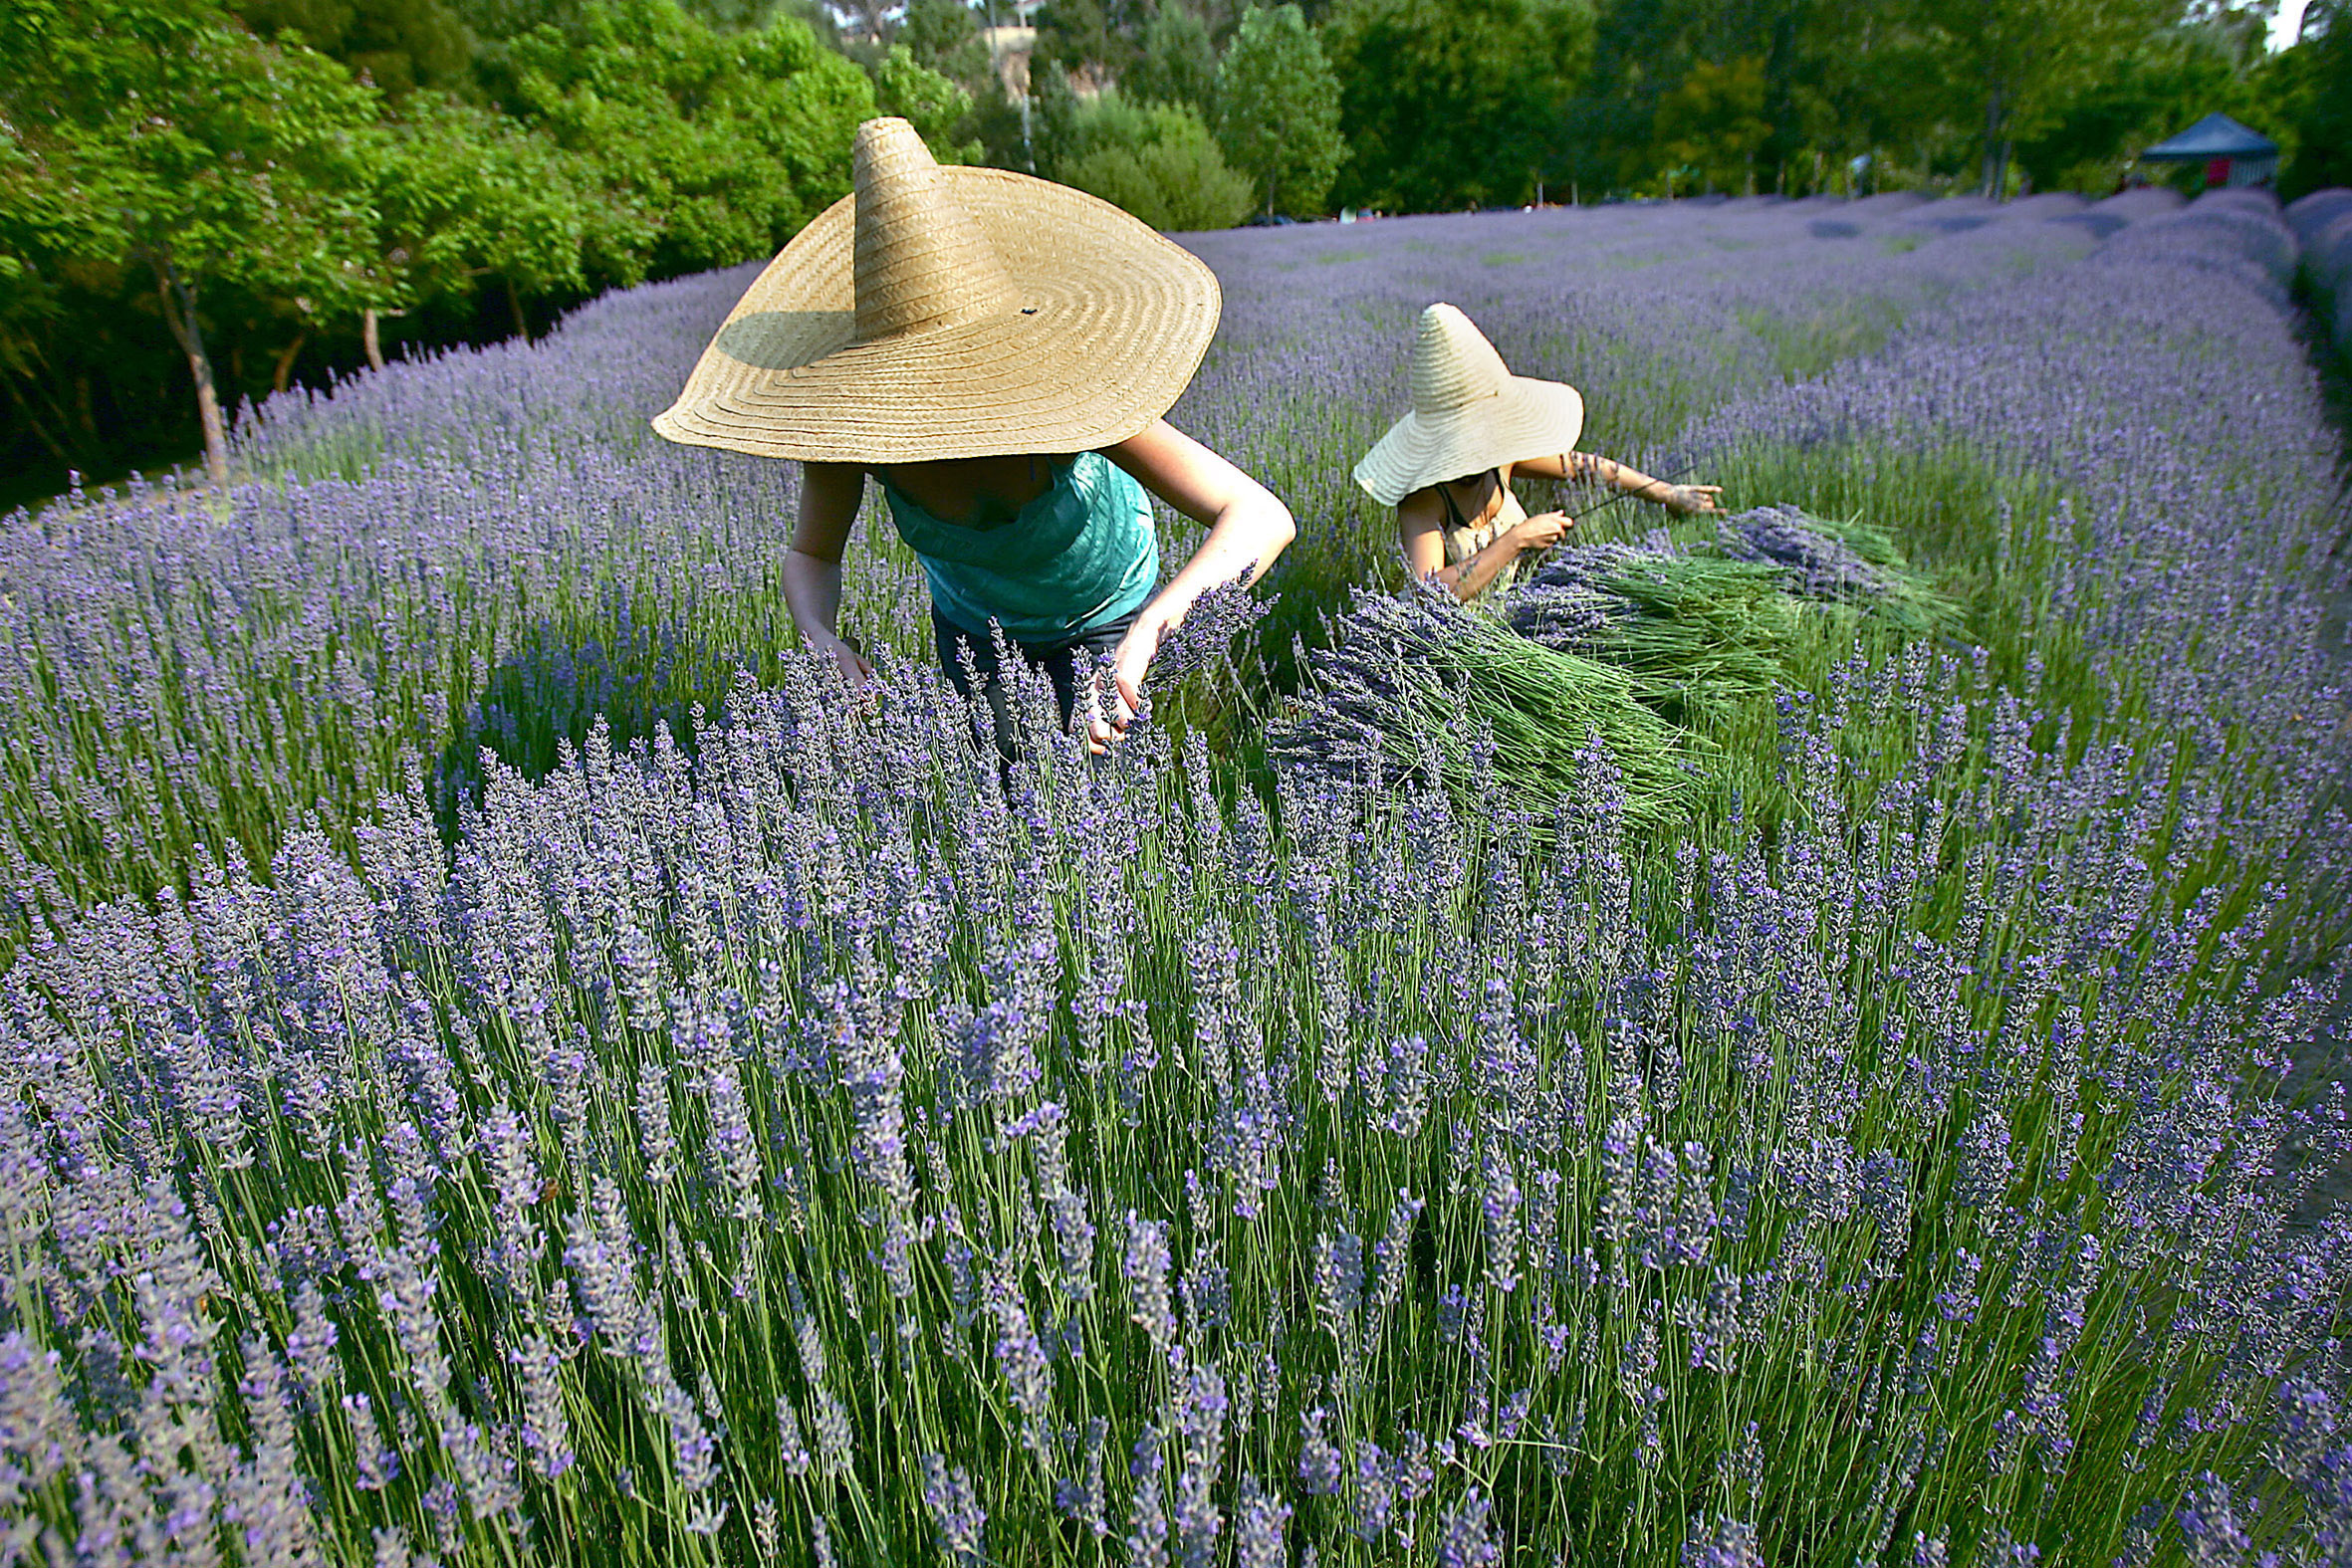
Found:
[0,202,2088,931]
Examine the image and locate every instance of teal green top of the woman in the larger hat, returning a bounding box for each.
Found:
[879,451,1159,642]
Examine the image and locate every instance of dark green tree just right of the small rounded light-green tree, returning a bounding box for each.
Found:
[1324,0,1592,212]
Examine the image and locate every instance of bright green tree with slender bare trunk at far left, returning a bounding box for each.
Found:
[0,0,395,484]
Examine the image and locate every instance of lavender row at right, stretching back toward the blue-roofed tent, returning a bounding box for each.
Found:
[1684,193,2352,799]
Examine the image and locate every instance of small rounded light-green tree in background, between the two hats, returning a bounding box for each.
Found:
[1216,5,1347,214]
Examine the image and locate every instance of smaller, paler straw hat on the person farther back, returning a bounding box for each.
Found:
[1355,306,1585,506]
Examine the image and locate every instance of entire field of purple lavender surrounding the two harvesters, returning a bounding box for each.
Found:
[0,193,2352,1568]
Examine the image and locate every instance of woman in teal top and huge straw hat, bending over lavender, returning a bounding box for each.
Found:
[654,119,1295,750]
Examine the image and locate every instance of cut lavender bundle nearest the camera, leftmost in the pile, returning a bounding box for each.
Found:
[1266,592,1701,827]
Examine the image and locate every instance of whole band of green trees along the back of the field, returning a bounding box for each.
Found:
[0,0,2352,494]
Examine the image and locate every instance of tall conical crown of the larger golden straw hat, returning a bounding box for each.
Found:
[851,119,1016,343]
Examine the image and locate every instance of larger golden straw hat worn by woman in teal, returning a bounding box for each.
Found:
[654,119,1221,463]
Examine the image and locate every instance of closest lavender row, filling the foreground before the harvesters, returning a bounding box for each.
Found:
[0,629,2352,1563]
